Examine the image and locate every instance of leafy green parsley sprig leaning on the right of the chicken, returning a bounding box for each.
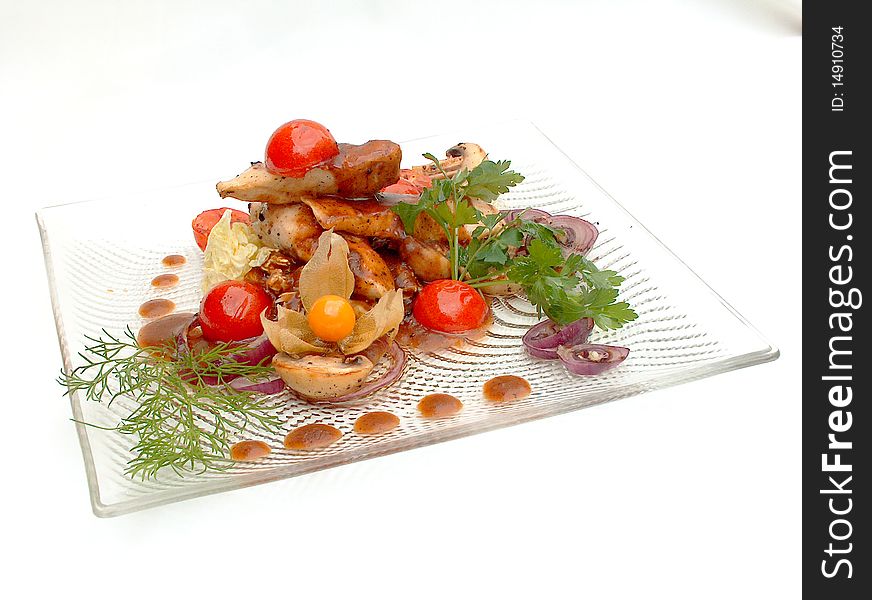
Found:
[394,154,638,329]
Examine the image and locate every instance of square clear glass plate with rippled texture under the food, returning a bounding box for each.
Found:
[37,123,778,516]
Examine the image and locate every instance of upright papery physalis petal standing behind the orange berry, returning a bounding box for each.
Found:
[300,230,354,310]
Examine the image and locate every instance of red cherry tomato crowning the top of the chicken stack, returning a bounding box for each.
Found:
[266,119,339,177]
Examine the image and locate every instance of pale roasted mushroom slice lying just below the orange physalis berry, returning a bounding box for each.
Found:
[272,352,375,398]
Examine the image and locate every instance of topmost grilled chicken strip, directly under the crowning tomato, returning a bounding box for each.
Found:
[216,140,403,204]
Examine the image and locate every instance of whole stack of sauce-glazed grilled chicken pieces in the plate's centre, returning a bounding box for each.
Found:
[217,140,495,302]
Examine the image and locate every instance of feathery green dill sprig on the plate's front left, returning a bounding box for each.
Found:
[58,328,279,479]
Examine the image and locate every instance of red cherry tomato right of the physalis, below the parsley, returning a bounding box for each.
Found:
[412,279,488,333]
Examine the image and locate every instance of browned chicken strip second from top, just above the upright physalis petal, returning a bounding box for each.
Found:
[302,197,406,240]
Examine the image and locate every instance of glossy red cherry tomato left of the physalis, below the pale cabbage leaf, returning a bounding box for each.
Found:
[200,281,272,342]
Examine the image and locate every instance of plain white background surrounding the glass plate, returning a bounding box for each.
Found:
[0,0,802,598]
